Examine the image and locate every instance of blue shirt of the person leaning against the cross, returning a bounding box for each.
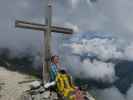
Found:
[50,64,58,81]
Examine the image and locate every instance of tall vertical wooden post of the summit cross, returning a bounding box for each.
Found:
[43,0,52,83]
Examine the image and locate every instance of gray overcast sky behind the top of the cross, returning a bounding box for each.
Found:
[0,0,133,51]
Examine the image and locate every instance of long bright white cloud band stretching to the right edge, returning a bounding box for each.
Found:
[69,35,133,61]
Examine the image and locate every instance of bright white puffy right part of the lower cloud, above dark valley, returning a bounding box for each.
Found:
[81,60,116,82]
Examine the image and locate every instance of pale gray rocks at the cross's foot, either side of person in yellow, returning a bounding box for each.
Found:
[21,84,95,100]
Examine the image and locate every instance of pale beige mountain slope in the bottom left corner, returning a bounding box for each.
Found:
[0,67,29,100]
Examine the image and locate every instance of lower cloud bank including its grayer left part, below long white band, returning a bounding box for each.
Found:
[65,49,117,83]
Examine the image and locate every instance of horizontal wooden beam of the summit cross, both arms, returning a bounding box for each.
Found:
[15,20,73,34]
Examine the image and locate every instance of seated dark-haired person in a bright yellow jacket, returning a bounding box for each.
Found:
[56,70,83,100]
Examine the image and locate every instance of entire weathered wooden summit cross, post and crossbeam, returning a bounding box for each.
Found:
[15,0,73,83]
